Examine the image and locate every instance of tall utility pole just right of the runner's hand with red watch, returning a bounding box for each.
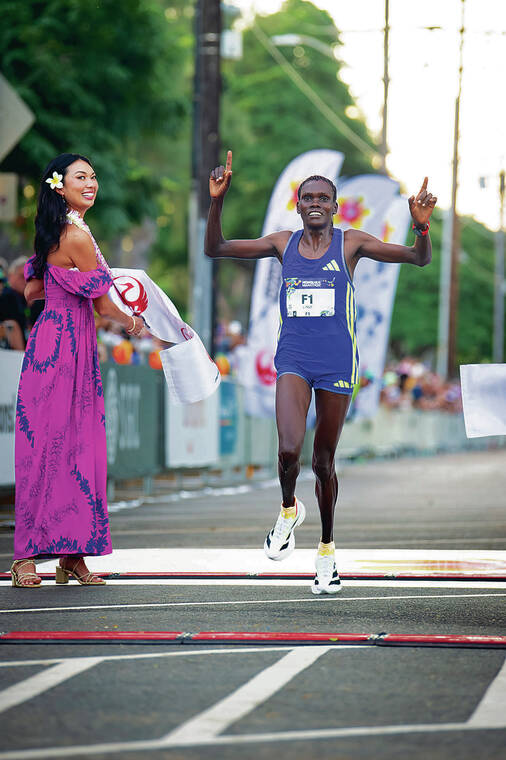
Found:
[446,0,466,377]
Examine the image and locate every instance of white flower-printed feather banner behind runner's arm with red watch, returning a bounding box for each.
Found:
[334,174,410,418]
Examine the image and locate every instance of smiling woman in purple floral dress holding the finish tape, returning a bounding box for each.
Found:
[11,153,143,588]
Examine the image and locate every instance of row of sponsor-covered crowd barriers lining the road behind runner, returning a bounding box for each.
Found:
[0,350,506,486]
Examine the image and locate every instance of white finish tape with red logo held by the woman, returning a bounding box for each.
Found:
[109,268,221,404]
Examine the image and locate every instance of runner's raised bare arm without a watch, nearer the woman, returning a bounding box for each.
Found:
[204,150,291,261]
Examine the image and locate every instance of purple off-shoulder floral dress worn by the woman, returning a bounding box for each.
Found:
[14,246,112,559]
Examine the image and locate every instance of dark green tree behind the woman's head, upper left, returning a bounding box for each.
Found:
[0,0,188,246]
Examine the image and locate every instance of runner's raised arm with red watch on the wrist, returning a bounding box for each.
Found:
[344,177,437,272]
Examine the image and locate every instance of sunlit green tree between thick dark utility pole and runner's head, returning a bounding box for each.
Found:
[221,0,374,237]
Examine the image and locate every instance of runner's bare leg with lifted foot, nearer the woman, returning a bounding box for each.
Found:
[276,374,311,507]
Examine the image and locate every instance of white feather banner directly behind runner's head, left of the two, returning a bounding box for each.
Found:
[236,150,344,417]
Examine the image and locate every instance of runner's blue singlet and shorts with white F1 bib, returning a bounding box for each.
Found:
[274,228,358,394]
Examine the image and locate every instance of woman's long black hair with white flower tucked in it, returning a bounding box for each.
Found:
[33,153,92,278]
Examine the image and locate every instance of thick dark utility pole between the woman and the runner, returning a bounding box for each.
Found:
[188,0,221,351]
